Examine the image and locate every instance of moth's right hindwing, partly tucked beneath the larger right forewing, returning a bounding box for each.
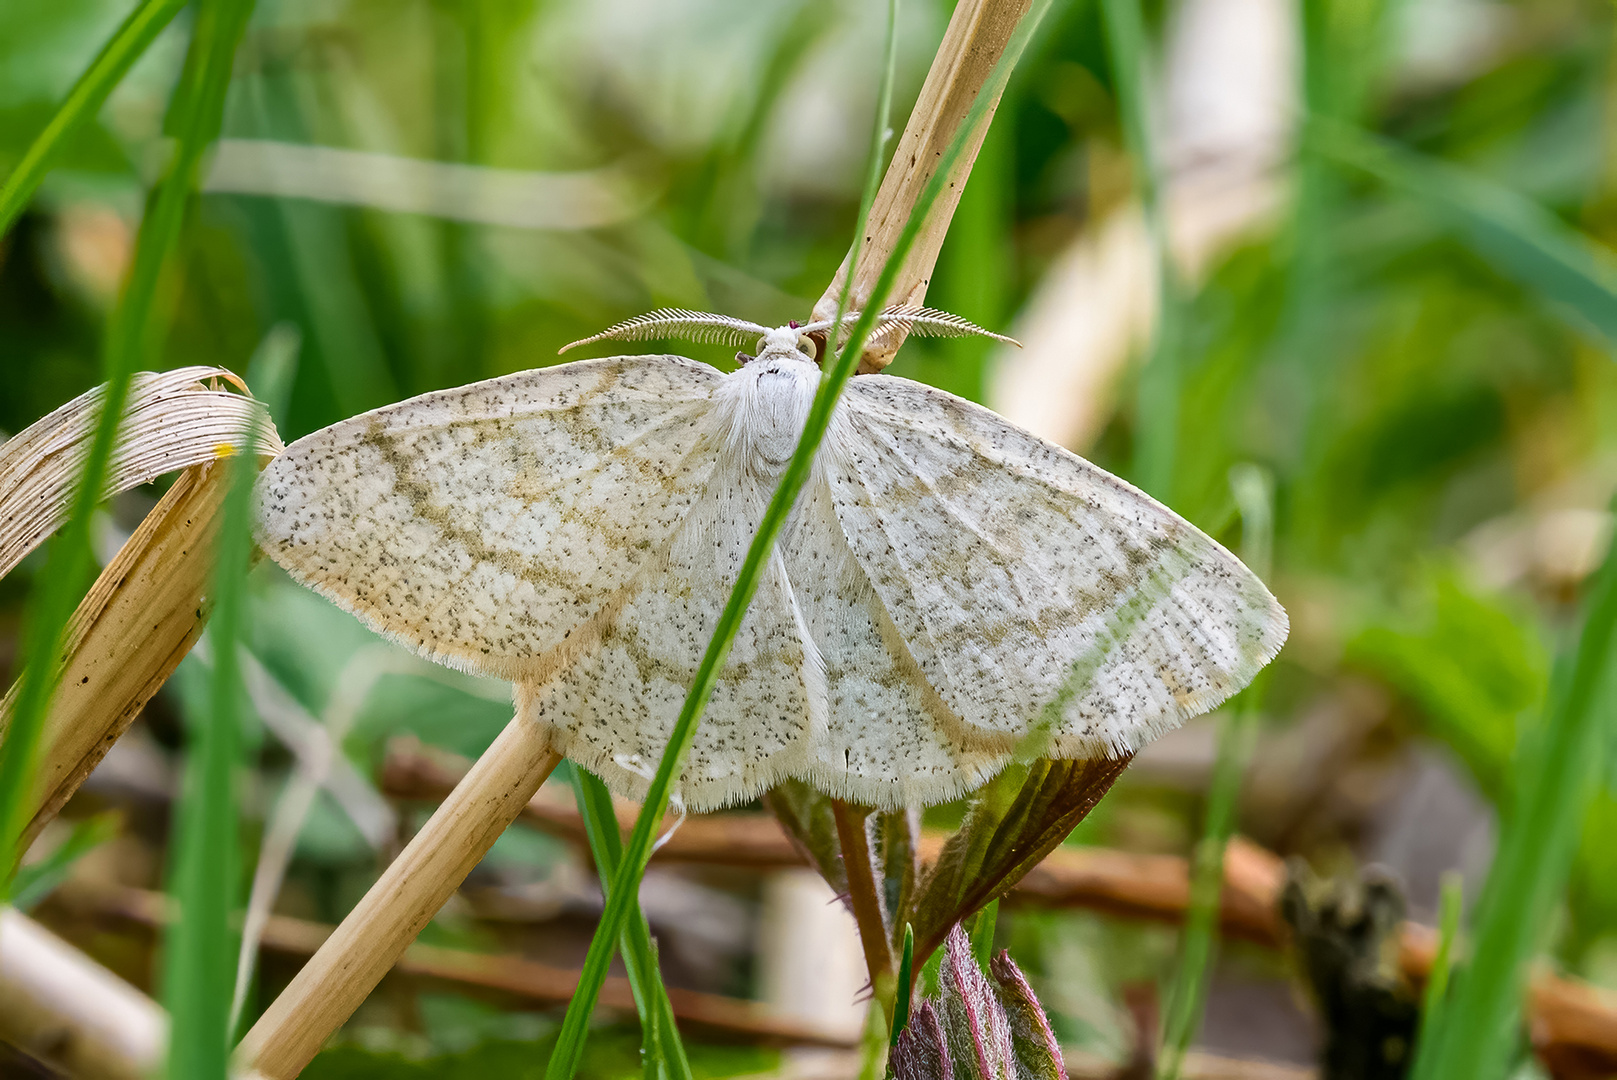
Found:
[781,469,1009,808]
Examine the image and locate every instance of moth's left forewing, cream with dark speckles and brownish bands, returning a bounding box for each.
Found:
[257,356,723,681]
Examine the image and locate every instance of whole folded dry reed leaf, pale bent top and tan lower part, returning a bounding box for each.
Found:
[0,367,281,849]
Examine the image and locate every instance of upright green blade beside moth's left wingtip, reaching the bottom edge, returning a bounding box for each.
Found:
[163,410,259,1080]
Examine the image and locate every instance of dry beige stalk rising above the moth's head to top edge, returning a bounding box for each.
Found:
[813,0,1032,373]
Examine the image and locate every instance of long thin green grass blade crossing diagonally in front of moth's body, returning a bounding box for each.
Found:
[545,0,1049,1080]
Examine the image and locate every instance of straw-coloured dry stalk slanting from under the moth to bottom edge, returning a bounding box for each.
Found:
[236,710,561,1080]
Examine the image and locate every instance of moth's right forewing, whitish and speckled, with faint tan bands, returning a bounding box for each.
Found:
[826,375,1287,757]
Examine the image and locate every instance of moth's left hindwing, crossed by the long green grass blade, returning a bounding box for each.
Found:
[519,459,826,810]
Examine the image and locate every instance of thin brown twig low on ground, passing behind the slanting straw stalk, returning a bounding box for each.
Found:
[50,883,852,1046]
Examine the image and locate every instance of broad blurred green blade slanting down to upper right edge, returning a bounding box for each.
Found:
[1307,120,1617,343]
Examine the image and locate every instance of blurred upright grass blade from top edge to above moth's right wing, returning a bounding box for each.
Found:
[1101,0,1184,500]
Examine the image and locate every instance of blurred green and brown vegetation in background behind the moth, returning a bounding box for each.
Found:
[0,0,1617,1077]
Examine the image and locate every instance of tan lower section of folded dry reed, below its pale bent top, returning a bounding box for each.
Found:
[0,462,230,850]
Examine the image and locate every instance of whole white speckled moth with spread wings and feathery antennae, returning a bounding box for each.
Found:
[257,309,1287,810]
